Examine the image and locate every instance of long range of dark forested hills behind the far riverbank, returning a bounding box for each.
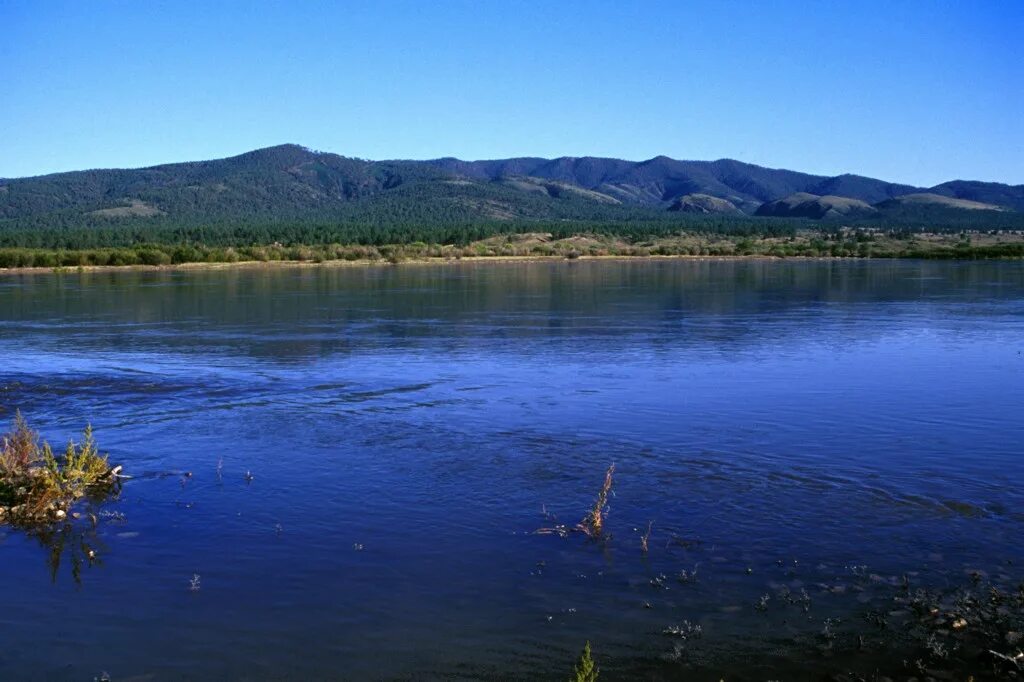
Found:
[0,144,1024,240]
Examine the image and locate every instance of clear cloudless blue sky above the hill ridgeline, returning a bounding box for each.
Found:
[0,0,1024,185]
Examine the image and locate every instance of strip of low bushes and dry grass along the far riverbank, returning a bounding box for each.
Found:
[0,229,1024,268]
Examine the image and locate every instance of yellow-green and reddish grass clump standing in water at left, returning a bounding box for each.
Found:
[0,413,120,525]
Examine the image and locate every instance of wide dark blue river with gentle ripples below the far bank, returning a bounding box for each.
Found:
[0,261,1024,680]
